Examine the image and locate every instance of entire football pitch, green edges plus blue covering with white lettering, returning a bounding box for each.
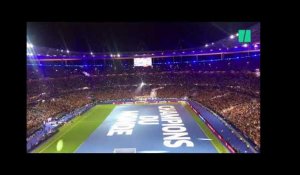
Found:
[32,103,229,153]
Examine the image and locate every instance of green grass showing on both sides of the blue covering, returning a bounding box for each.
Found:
[32,104,229,153]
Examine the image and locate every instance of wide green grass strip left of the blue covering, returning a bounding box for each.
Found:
[33,104,115,153]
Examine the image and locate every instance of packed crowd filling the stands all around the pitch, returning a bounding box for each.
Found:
[27,58,260,146]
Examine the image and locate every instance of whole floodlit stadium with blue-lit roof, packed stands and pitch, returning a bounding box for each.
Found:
[26,23,260,153]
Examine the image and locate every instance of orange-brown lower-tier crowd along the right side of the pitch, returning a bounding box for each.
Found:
[157,86,260,146]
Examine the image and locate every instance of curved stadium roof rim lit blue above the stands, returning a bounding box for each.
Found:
[27,23,260,61]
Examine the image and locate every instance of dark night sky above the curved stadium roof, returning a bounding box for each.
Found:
[27,22,256,52]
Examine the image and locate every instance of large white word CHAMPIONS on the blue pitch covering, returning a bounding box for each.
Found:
[158,105,194,148]
